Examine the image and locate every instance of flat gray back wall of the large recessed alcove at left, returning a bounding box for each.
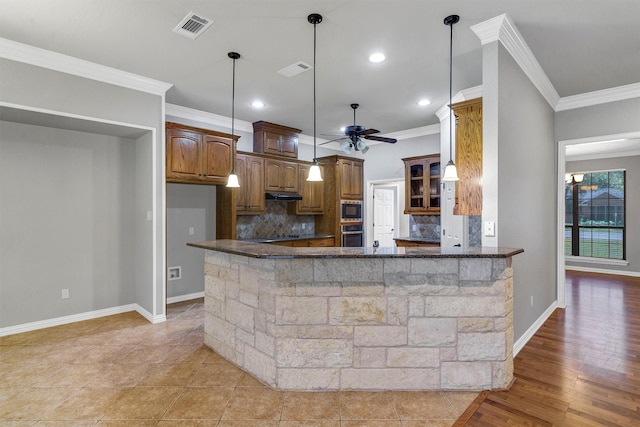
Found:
[0,122,136,327]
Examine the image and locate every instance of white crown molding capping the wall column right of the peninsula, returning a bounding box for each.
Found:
[471,13,560,110]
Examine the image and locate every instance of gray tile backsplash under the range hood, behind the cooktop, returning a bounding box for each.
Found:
[236,200,315,240]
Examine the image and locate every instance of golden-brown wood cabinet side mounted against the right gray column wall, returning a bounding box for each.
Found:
[452,98,482,215]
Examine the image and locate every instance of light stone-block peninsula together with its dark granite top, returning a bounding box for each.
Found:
[190,240,522,391]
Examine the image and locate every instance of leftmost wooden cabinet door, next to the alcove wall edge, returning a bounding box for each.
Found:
[167,129,202,181]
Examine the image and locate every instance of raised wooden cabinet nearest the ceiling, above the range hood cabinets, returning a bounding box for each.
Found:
[253,121,301,159]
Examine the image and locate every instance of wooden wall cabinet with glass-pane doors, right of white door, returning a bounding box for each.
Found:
[402,154,440,215]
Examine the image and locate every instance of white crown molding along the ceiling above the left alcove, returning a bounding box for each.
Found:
[0,37,173,96]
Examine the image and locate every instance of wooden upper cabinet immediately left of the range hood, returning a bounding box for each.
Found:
[235,154,265,215]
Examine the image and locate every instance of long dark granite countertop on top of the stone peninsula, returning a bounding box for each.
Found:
[187,240,524,259]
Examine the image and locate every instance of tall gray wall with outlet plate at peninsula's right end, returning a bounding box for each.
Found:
[482,42,557,340]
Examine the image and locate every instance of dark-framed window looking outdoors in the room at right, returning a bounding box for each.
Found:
[564,170,626,260]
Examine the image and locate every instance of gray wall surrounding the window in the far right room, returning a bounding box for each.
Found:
[566,156,640,273]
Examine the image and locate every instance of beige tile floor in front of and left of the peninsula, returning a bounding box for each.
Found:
[0,300,478,427]
